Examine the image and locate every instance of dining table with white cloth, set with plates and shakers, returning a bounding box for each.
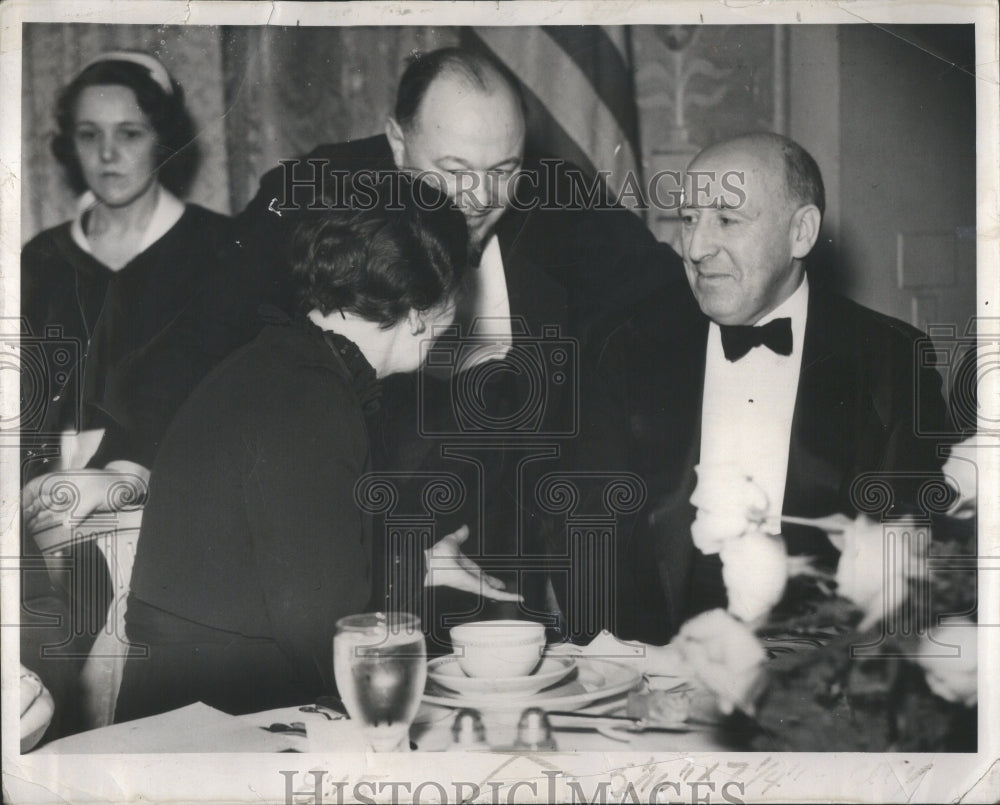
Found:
[34,636,724,755]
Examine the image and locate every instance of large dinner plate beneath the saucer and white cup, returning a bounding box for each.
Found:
[424,657,642,710]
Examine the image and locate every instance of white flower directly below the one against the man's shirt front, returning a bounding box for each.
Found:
[719,529,788,623]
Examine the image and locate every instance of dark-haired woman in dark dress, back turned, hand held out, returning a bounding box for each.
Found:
[115,175,518,721]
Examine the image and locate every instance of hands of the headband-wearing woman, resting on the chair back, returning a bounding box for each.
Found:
[21,461,149,533]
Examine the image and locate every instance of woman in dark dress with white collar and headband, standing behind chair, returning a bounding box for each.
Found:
[20,51,234,738]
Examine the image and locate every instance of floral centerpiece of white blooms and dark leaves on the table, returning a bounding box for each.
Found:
[671,446,977,752]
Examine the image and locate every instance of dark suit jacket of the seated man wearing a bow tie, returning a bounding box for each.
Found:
[583,283,945,643]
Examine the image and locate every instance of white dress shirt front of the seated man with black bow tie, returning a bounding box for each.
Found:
[700,278,809,533]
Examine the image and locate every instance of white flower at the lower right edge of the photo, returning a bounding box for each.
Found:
[916,621,979,707]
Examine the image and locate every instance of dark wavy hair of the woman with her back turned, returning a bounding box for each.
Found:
[291,172,468,328]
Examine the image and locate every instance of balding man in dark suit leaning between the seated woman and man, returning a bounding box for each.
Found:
[212,48,685,640]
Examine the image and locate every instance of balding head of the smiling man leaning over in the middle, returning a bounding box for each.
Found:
[386,48,525,247]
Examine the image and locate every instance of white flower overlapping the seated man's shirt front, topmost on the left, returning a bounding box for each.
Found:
[691,464,770,555]
